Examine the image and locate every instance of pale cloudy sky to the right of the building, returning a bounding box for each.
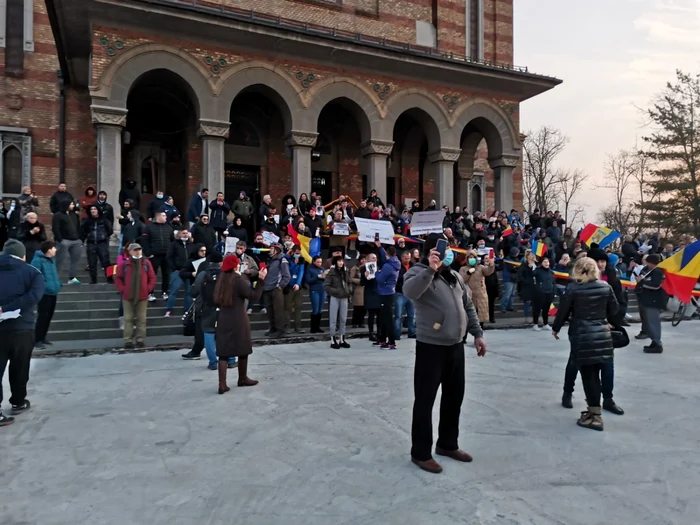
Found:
[514,0,700,222]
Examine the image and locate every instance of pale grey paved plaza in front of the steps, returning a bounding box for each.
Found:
[0,322,700,525]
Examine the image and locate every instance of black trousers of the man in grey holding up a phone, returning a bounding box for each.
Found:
[411,341,464,461]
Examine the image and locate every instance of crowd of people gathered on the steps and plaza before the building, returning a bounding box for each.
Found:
[0,183,696,452]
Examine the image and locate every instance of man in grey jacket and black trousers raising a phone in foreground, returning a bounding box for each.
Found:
[403,234,486,474]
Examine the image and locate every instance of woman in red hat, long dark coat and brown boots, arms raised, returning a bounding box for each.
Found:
[214,255,267,394]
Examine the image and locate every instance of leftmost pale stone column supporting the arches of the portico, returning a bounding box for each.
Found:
[90,105,127,244]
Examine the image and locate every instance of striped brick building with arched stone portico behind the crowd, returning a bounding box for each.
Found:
[0,0,559,229]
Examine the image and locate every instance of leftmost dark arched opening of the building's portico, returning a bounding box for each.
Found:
[122,69,201,216]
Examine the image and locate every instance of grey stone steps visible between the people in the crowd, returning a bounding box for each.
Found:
[48,248,638,341]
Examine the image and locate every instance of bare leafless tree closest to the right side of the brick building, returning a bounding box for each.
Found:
[523,126,569,212]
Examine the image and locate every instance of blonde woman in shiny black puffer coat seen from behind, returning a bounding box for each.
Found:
[552,257,618,430]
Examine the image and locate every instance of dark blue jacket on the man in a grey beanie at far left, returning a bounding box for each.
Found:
[0,255,44,333]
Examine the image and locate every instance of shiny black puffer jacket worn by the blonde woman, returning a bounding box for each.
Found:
[552,281,618,366]
